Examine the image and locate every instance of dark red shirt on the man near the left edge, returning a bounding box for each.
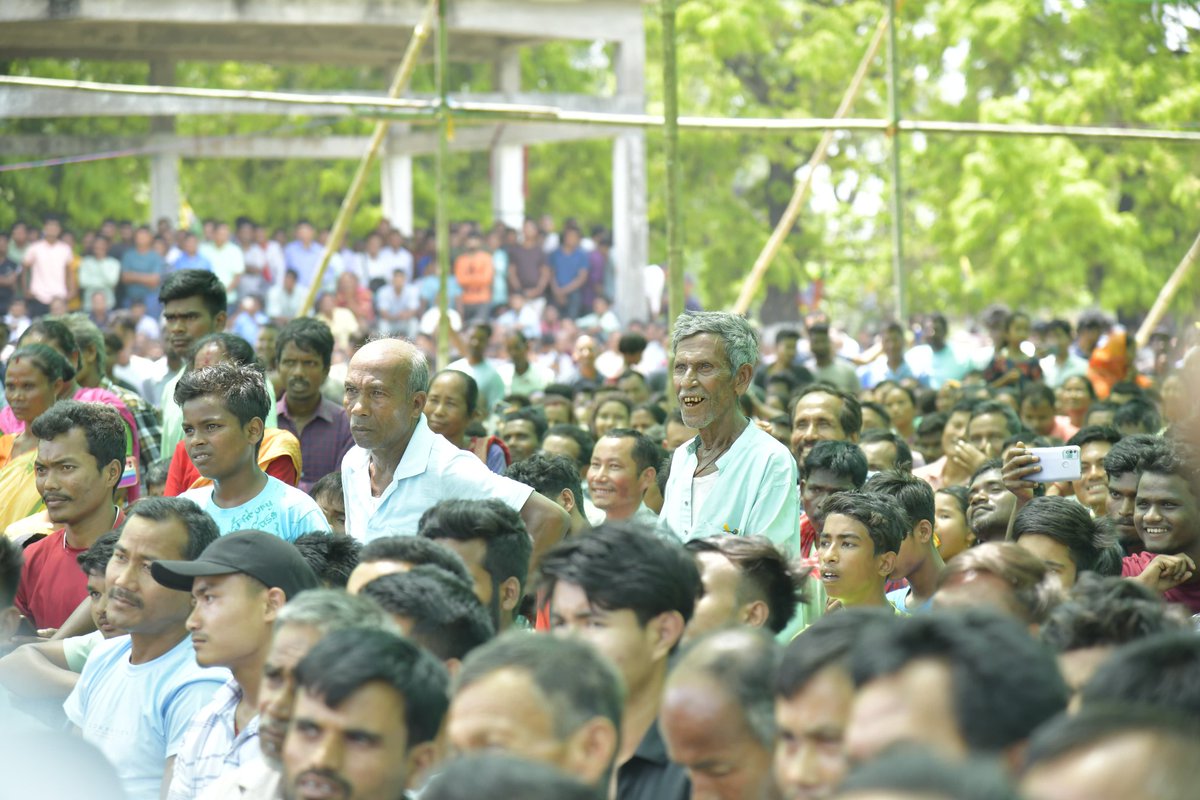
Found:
[13,511,125,628]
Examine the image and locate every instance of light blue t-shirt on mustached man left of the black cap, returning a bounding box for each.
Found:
[62,636,229,800]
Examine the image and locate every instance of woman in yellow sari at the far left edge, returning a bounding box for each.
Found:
[0,344,74,533]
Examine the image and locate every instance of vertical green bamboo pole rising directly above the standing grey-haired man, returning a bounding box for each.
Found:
[661,0,684,347]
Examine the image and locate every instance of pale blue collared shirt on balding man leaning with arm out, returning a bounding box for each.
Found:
[342,414,533,542]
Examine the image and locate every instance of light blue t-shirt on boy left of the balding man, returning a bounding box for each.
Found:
[179,475,332,542]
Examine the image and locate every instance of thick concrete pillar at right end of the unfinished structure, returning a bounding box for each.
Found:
[612,30,649,321]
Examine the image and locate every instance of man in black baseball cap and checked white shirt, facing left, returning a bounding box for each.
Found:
[150,530,320,800]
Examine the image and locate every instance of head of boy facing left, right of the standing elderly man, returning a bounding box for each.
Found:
[817,492,905,613]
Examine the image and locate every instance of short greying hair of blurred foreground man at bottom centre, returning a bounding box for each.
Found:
[454,631,625,739]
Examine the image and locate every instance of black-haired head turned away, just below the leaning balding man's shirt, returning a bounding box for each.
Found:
[416,500,533,633]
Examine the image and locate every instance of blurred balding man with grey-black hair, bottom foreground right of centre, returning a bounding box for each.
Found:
[660,628,779,800]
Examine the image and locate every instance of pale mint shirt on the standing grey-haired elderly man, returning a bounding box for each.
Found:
[659,422,800,557]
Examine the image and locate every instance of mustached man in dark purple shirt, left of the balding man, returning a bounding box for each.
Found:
[275,318,354,492]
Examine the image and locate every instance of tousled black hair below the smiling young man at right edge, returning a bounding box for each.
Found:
[1040,575,1187,652]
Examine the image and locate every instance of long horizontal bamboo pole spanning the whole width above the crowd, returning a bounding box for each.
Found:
[7,76,1200,144]
